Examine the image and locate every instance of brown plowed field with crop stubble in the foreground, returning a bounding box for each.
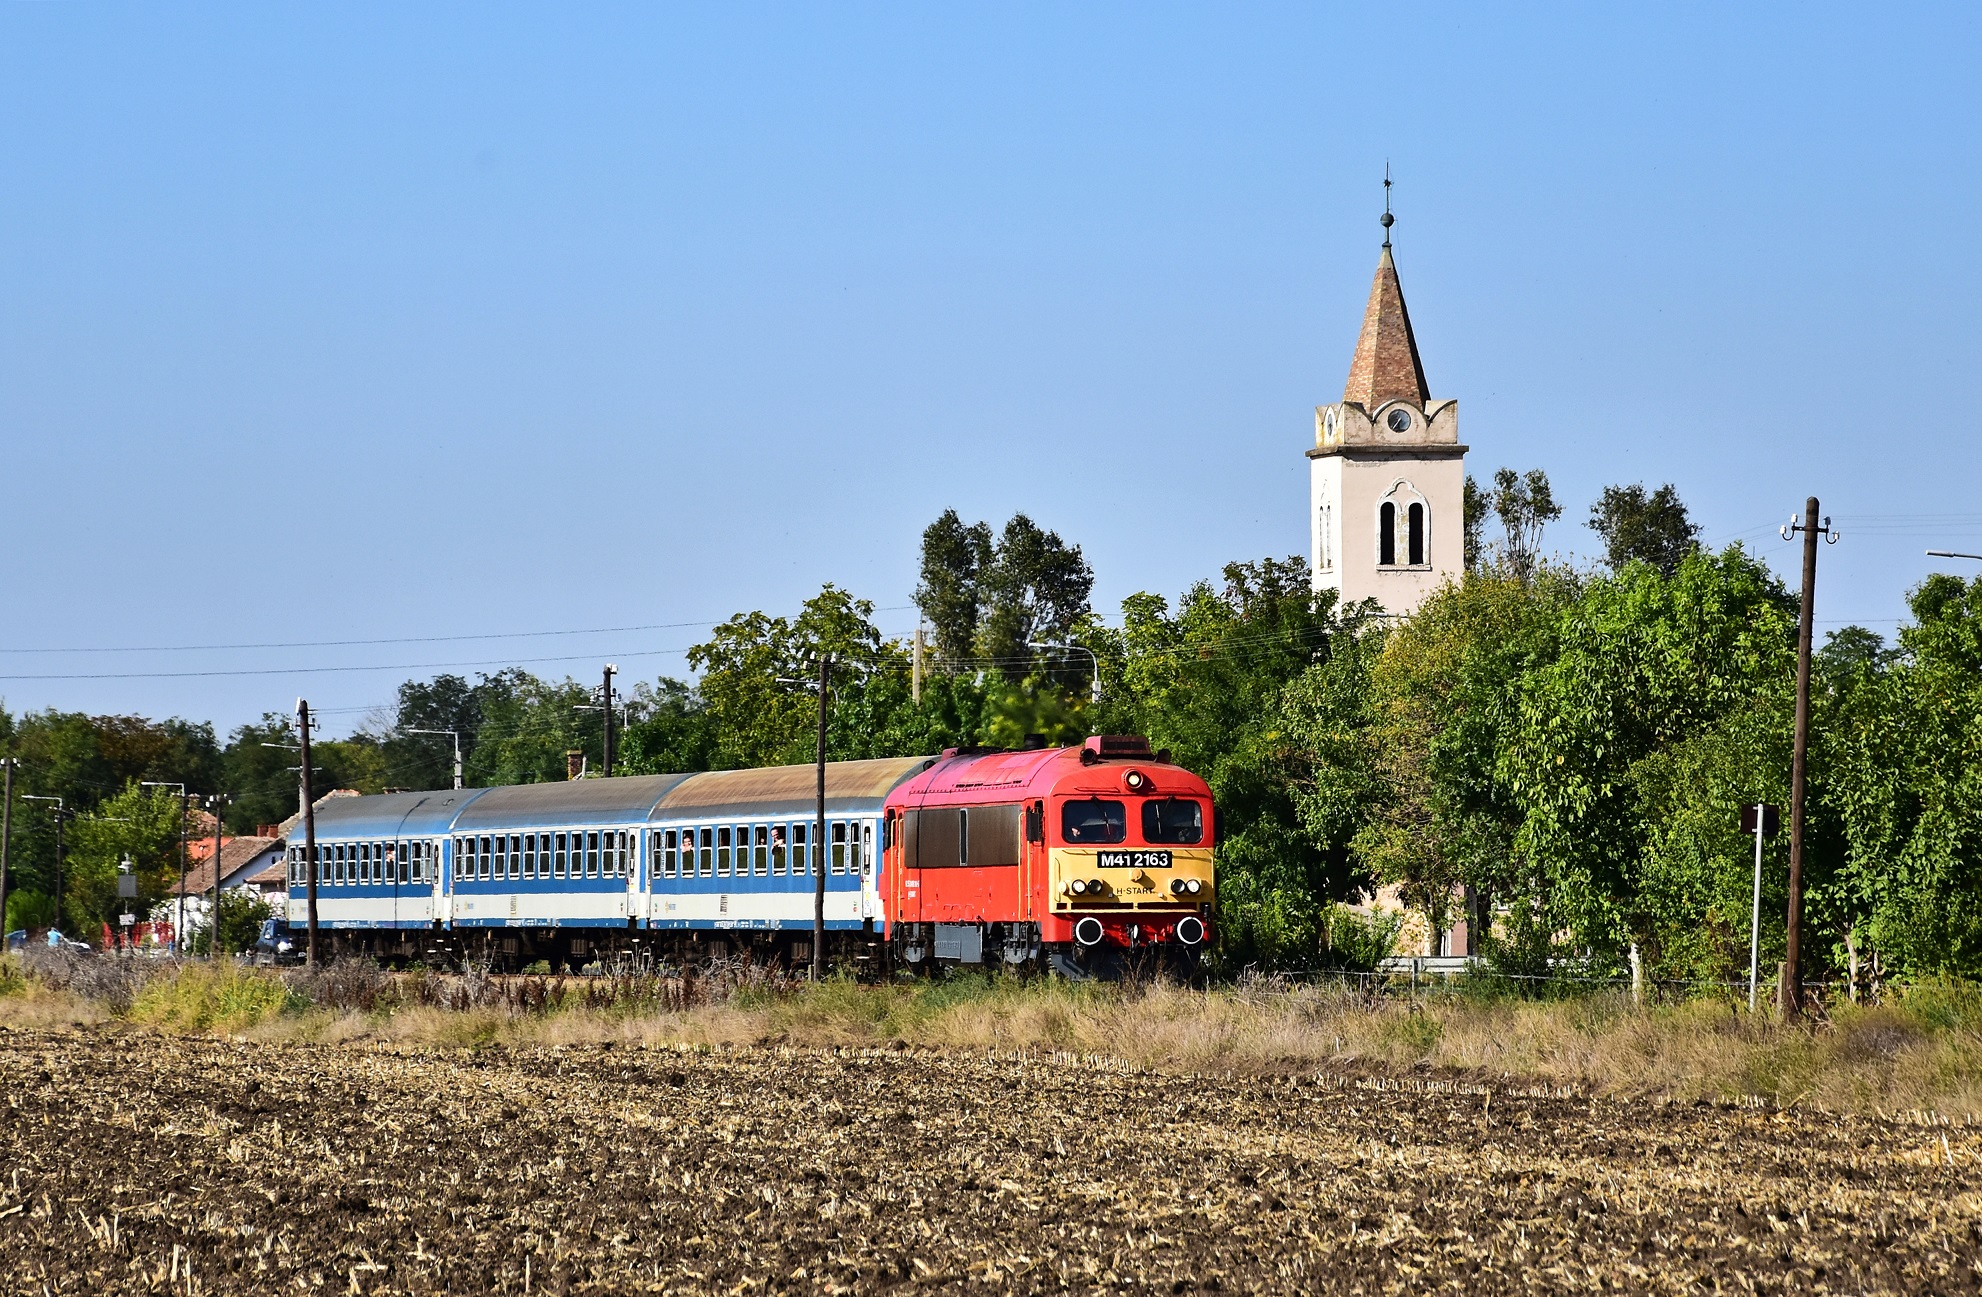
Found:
[0,1031,1982,1293]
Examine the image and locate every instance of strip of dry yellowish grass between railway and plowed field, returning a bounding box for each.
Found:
[0,966,1982,1120]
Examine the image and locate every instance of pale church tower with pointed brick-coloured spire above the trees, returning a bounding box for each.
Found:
[1308,207,1467,617]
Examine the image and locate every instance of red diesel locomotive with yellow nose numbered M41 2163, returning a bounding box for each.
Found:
[882,736,1217,976]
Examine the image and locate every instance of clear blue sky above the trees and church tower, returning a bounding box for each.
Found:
[0,2,1982,741]
